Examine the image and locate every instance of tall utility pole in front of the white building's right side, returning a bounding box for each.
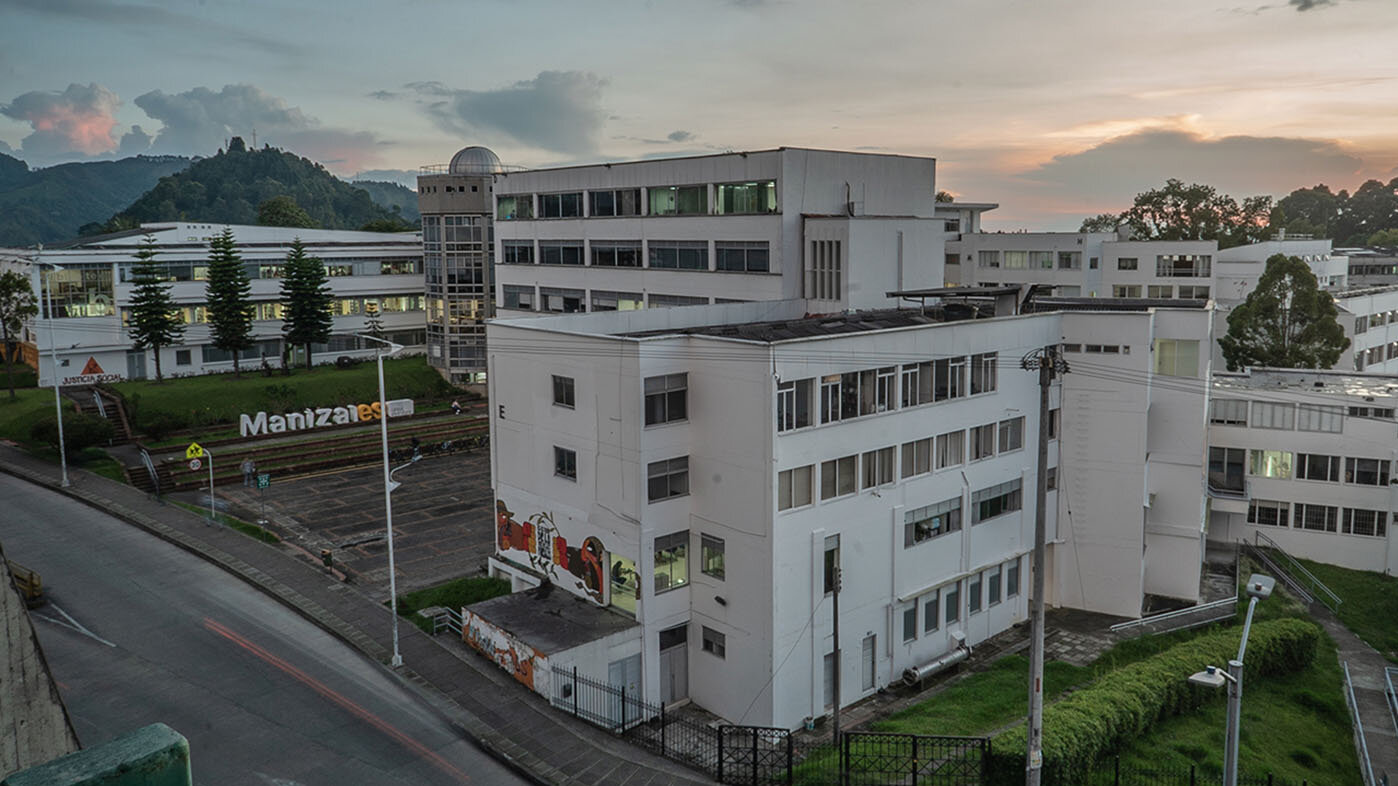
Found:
[1019,344,1068,786]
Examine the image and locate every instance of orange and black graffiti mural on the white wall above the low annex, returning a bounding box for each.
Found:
[495,499,607,604]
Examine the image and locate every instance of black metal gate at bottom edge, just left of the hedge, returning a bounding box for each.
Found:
[840,731,990,786]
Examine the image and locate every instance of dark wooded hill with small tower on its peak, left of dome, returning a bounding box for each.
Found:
[105,144,394,229]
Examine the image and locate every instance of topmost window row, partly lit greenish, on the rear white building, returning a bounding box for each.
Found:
[495,180,777,221]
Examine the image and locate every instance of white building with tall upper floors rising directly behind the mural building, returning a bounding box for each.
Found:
[495,147,950,316]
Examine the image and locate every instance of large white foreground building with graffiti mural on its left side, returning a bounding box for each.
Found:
[473,292,1211,727]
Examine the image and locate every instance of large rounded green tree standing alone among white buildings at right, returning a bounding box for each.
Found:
[1219,255,1349,371]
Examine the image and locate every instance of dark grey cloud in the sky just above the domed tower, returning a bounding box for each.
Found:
[407,71,607,154]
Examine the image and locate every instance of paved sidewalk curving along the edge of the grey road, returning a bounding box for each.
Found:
[0,445,710,785]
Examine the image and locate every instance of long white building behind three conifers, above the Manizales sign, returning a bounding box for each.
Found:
[0,221,425,385]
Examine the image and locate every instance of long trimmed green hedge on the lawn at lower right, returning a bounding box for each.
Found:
[988,618,1321,786]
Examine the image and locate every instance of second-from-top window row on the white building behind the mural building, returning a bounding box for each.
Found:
[500,241,772,273]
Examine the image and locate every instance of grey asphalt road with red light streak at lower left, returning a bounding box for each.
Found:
[0,476,523,786]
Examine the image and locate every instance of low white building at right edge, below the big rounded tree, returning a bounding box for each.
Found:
[1208,369,1398,573]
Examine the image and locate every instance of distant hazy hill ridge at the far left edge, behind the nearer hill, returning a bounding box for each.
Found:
[0,154,190,246]
